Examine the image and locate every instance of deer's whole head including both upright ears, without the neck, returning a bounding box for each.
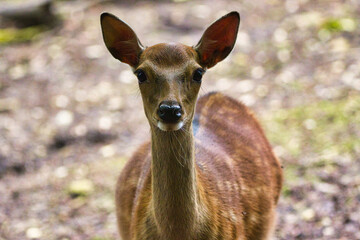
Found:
[101,12,240,131]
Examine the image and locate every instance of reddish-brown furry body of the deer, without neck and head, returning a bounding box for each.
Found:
[116,93,282,240]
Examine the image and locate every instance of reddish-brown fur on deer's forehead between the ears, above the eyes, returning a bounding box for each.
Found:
[140,43,196,67]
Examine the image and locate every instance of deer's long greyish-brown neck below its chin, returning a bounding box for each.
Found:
[151,124,199,239]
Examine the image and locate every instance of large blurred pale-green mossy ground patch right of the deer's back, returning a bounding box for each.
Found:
[264,96,360,165]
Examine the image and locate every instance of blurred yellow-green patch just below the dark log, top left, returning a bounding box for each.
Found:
[0,26,44,44]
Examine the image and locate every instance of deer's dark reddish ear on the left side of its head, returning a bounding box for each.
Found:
[100,13,144,67]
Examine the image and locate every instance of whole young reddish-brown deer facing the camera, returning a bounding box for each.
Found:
[101,12,282,240]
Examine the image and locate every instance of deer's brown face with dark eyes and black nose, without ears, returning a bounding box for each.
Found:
[134,43,205,131]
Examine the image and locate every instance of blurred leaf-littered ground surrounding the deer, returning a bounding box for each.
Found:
[0,0,360,240]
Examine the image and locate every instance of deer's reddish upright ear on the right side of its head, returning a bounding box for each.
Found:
[194,12,240,68]
